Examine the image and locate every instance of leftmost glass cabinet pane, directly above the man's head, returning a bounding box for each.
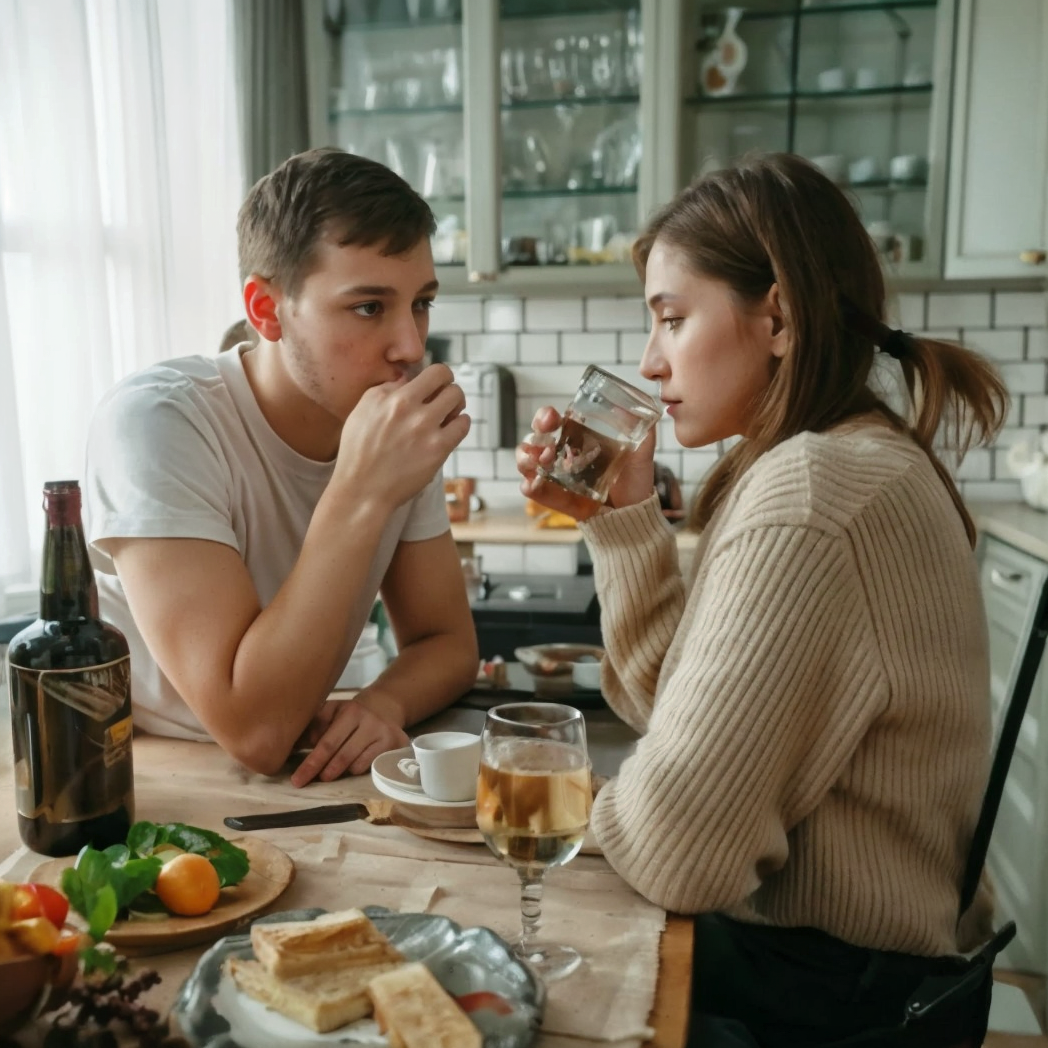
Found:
[307,0,467,266]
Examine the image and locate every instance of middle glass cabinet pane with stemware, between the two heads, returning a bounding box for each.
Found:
[497,0,643,267]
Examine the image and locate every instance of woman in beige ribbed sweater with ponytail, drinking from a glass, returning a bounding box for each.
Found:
[518,154,1007,1048]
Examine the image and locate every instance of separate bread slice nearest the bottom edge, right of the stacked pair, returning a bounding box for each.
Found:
[368,961,482,1048]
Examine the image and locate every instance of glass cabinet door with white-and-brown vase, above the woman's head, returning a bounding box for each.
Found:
[680,0,953,276]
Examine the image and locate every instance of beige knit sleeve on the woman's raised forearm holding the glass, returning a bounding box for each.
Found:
[580,496,684,733]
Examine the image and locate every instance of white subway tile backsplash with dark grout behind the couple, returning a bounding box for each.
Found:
[431,290,1048,511]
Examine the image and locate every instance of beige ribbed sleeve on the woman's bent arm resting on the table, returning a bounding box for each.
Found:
[592,524,888,913]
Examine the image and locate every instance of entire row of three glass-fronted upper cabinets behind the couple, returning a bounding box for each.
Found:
[306,0,959,294]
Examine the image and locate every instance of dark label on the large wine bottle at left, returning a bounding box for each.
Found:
[8,655,134,824]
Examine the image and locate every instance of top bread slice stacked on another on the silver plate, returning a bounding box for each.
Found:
[252,910,403,979]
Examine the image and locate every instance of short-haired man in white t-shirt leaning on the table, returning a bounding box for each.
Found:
[86,149,478,786]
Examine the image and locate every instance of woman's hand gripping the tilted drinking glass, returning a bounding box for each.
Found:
[517,407,655,521]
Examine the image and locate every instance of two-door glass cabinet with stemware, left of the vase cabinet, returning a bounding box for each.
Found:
[306,0,659,290]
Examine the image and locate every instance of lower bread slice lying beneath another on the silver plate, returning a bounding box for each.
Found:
[225,957,402,1043]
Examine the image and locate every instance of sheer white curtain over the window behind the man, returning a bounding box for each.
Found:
[0,0,243,614]
